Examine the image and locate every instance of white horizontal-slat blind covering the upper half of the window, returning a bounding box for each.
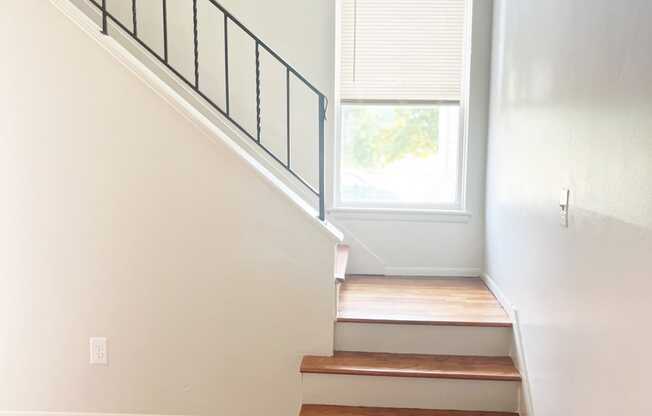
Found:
[341,0,466,101]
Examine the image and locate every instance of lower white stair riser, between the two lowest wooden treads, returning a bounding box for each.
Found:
[302,374,519,412]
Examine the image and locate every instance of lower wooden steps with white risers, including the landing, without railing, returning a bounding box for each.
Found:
[300,276,521,416]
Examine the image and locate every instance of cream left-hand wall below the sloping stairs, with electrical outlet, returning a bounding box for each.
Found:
[0,0,333,416]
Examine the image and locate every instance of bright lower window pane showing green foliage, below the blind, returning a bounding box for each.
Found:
[340,104,460,207]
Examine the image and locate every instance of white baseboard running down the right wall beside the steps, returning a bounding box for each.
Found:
[480,273,534,416]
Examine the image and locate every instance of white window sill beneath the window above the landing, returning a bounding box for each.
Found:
[327,207,472,223]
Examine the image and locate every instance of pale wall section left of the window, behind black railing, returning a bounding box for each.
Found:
[72,0,335,207]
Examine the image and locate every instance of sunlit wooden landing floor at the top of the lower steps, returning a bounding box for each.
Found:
[337,276,512,327]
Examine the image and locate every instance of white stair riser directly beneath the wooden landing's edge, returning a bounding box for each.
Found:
[335,322,512,356]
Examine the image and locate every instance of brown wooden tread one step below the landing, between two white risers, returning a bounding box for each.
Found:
[301,351,521,381]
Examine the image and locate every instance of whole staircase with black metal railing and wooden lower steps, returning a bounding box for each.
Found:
[57,0,521,416]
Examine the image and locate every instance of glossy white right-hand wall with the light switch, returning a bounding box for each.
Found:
[487,0,652,416]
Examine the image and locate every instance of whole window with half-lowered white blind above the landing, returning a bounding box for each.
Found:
[336,0,466,209]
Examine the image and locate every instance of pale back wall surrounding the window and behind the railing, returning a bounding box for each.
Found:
[74,0,492,275]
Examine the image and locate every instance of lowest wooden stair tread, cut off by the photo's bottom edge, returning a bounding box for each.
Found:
[300,404,518,416]
